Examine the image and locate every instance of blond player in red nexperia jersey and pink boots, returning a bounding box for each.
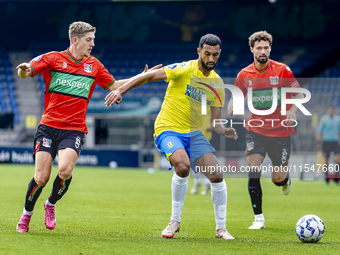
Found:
[17,22,159,232]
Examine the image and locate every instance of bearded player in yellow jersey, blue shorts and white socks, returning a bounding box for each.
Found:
[105,34,237,240]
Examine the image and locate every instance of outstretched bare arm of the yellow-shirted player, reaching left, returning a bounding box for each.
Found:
[105,68,167,107]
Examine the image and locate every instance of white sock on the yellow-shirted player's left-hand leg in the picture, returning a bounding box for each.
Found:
[171,173,188,222]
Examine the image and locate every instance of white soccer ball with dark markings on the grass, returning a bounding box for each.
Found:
[295,214,325,243]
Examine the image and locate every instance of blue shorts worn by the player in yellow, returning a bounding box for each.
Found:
[155,130,216,171]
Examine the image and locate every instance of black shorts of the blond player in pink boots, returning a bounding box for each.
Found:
[33,124,85,160]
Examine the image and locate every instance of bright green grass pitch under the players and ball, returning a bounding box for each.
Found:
[0,164,340,254]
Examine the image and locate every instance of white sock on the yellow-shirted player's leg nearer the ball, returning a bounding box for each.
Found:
[211,180,227,230]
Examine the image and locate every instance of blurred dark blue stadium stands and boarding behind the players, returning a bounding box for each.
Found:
[0,0,340,179]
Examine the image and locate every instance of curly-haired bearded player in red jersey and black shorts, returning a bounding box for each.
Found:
[228,31,303,229]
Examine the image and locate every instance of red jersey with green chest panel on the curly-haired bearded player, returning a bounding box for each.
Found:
[235,59,300,137]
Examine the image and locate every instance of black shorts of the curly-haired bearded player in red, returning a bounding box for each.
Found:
[246,131,290,166]
